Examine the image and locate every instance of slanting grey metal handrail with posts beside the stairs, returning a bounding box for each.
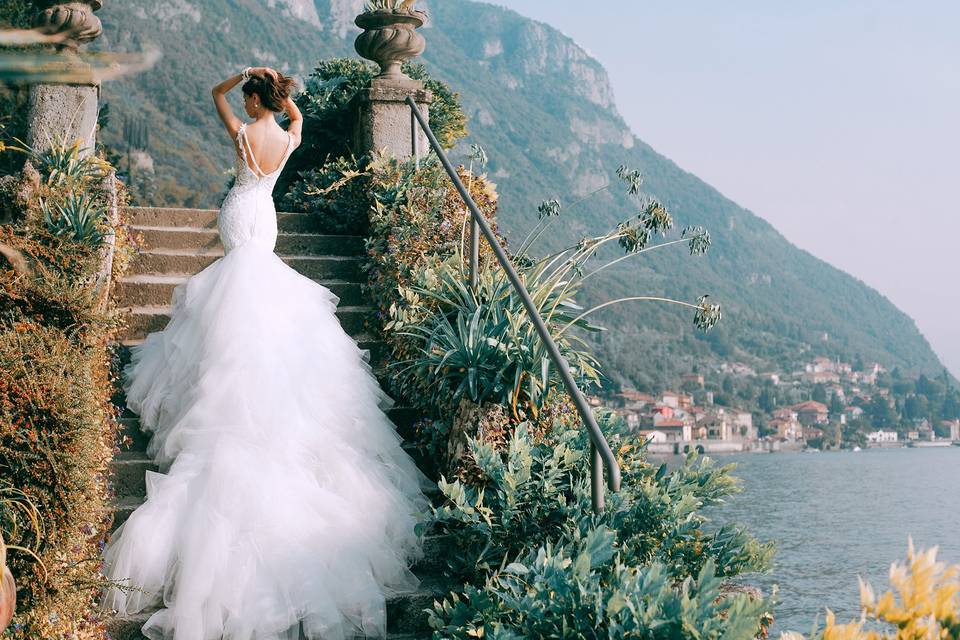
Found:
[407,97,620,513]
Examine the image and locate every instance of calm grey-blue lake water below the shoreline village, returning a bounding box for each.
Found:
[696,447,960,637]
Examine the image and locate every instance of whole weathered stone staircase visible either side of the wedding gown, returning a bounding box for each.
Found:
[108,207,448,640]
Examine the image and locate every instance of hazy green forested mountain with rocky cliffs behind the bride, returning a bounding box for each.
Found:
[92,0,943,388]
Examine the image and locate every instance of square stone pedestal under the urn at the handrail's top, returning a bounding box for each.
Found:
[352,78,433,159]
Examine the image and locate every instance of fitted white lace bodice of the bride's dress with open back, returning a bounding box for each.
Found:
[217,123,294,253]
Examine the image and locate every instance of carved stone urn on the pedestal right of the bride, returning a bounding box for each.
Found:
[354,10,427,84]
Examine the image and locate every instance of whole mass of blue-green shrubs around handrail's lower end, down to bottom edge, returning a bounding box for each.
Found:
[431,416,772,638]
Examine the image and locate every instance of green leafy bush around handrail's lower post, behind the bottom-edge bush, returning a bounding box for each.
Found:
[433,416,772,580]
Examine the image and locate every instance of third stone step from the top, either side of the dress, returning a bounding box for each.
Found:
[130,249,363,282]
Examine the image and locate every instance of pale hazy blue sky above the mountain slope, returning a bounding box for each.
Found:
[495,0,960,376]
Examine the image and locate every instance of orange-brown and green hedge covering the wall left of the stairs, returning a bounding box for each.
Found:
[0,142,130,640]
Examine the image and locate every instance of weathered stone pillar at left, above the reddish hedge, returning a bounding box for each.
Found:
[27,79,100,156]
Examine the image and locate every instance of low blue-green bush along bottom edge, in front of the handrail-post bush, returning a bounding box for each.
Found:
[430,544,771,640]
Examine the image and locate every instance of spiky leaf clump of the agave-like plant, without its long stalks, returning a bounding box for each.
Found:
[386,253,599,417]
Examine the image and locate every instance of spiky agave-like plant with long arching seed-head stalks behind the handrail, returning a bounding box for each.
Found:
[385,161,722,418]
